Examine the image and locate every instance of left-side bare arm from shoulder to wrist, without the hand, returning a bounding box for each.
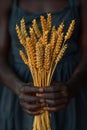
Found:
[0,0,22,94]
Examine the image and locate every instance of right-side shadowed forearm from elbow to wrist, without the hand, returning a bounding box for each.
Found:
[67,57,87,92]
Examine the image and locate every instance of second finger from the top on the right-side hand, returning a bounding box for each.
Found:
[38,93,67,100]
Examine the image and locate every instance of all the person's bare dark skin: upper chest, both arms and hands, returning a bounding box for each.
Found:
[0,0,87,115]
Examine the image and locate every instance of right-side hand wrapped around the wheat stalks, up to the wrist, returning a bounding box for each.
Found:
[38,83,70,112]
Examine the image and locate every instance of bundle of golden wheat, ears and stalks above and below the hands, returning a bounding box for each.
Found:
[16,13,75,130]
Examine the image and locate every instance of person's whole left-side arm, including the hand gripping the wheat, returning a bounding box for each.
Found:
[0,0,43,115]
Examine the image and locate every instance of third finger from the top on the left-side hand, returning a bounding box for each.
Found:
[20,102,44,111]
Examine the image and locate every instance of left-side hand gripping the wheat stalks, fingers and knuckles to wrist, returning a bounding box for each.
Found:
[18,84,44,115]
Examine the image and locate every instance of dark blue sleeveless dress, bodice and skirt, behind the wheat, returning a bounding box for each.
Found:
[0,0,87,130]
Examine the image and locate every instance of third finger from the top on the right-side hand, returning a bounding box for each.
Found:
[45,98,68,107]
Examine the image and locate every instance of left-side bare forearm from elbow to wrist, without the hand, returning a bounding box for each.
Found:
[0,60,22,94]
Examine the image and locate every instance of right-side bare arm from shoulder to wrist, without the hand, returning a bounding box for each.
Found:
[67,0,87,94]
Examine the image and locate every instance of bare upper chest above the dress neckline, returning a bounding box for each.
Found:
[18,0,79,12]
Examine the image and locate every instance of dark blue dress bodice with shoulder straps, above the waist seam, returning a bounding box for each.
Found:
[9,0,80,82]
